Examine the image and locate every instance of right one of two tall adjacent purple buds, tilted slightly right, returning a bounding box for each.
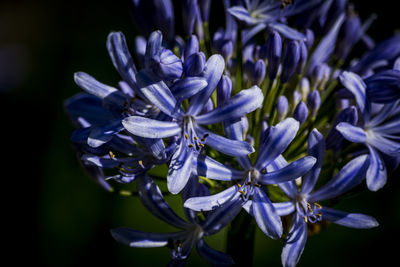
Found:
[281,41,300,84]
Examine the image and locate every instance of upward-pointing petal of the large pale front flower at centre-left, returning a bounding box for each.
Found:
[186,55,225,116]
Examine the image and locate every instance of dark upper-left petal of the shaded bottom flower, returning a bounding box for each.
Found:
[137,175,190,229]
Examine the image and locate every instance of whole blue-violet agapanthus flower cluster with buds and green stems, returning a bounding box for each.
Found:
[65,0,400,266]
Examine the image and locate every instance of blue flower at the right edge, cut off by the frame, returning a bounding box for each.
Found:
[336,72,400,191]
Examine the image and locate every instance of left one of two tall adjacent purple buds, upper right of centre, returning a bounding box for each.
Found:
[266,31,282,80]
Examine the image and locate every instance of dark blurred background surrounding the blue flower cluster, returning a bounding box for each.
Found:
[0,0,400,266]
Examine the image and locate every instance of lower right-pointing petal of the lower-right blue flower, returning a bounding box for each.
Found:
[321,207,379,229]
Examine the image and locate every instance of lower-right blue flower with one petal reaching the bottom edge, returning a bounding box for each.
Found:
[270,129,378,267]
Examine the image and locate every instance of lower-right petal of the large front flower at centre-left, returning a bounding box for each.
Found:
[196,126,254,157]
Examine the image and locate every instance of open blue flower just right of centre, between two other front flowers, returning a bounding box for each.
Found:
[184,118,315,239]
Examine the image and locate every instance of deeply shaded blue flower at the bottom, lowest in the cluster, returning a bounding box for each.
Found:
[111,176,241,266]
